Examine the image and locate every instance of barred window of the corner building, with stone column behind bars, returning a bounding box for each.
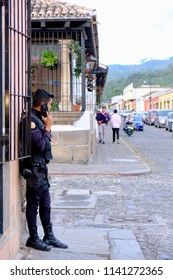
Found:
[31,29,86,111]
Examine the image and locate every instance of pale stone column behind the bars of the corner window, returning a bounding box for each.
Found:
[59,39,72,111]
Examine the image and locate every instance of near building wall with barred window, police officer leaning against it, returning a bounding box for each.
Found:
[0,0,31,259]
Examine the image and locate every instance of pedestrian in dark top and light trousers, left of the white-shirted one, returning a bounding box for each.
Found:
[96,105,110,144]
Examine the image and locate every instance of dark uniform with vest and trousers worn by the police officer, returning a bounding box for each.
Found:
[26,109,52,228]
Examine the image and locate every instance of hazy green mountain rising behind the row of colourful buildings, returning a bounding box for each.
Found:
[102,57,173,102]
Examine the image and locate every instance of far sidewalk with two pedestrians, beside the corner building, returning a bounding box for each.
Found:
[49,127,150,176]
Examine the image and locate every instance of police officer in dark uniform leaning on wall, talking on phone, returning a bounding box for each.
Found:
[26,89,68,251]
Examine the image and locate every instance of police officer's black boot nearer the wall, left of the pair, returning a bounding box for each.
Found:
[26,228,51,251]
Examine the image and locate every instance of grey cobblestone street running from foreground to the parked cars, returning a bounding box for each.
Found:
[16,126,173,260]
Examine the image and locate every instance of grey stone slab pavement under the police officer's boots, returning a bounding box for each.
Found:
[16,228,145,260]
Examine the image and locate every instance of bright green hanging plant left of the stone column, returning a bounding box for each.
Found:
[41,50,59,67]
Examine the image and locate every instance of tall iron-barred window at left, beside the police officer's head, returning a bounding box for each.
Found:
[0,0,31,234]
